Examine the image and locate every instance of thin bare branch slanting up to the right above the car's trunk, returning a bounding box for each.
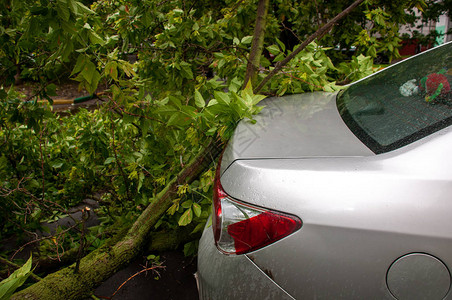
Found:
[254,0,364,94]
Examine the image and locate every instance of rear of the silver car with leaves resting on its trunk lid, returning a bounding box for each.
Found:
[197,43,452,299]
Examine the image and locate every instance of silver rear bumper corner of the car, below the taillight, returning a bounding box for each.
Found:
[196,223,294,300]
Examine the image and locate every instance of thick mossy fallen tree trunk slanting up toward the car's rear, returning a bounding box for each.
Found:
[11,141,221,299]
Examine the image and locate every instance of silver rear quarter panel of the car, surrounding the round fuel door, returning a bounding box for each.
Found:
[221,128,452,299]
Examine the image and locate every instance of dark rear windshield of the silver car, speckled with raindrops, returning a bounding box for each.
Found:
[337,43,452,153]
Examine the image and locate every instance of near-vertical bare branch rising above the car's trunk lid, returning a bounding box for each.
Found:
[243,0,270,88]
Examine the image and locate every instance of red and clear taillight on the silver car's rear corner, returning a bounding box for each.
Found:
[212,161,302,254]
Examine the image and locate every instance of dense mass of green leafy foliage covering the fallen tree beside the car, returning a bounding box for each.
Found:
[0,0,421,270]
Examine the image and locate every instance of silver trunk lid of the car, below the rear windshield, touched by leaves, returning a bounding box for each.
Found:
[221,92,375,173]
